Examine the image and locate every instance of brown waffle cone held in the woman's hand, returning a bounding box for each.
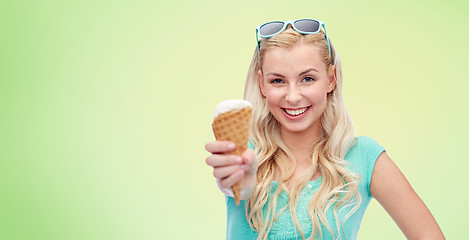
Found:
[212,107,252,205]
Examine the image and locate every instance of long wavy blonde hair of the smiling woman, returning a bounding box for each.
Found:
[244,27,361,239]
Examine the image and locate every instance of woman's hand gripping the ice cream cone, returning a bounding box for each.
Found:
[205,141,257,200]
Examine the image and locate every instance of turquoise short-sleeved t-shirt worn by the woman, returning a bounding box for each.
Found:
[226,136,385,240]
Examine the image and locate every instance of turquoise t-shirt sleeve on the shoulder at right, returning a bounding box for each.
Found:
[359,136,386,196]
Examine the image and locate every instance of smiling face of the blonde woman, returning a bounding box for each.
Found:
[258,43,335,137]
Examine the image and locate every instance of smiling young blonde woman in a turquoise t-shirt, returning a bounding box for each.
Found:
[205,19,444,239]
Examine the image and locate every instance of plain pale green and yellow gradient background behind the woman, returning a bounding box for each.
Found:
[0,0,469,239]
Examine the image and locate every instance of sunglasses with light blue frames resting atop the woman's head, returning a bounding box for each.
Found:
[256,19,332,61]
